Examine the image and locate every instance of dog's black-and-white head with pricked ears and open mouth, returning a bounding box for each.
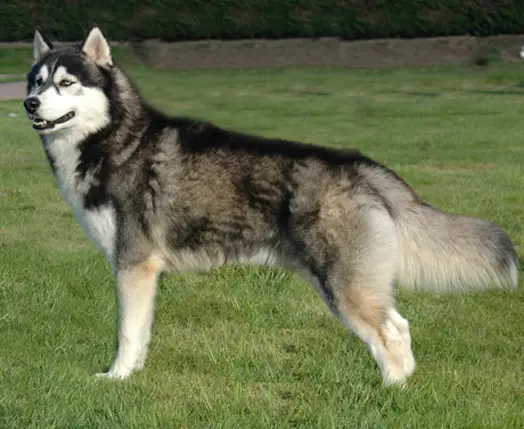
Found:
[24,27,113,135]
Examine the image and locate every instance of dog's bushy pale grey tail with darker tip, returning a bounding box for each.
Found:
[395,202,518,292]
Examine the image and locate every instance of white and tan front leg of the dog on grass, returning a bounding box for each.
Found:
[97,256,164,379]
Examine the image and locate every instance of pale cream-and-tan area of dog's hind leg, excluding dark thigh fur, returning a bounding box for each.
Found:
[334,210,415,385]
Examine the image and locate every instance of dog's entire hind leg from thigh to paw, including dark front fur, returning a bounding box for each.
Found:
[294,207,415,385]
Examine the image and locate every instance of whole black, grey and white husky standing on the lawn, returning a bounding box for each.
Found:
[24,27,518,385]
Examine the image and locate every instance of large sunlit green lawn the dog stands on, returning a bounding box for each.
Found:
[0,56,524,429]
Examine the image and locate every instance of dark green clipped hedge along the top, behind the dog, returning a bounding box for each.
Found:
[0,0,524,41]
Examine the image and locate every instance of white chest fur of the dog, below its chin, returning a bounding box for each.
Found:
[47,137,116,261]
